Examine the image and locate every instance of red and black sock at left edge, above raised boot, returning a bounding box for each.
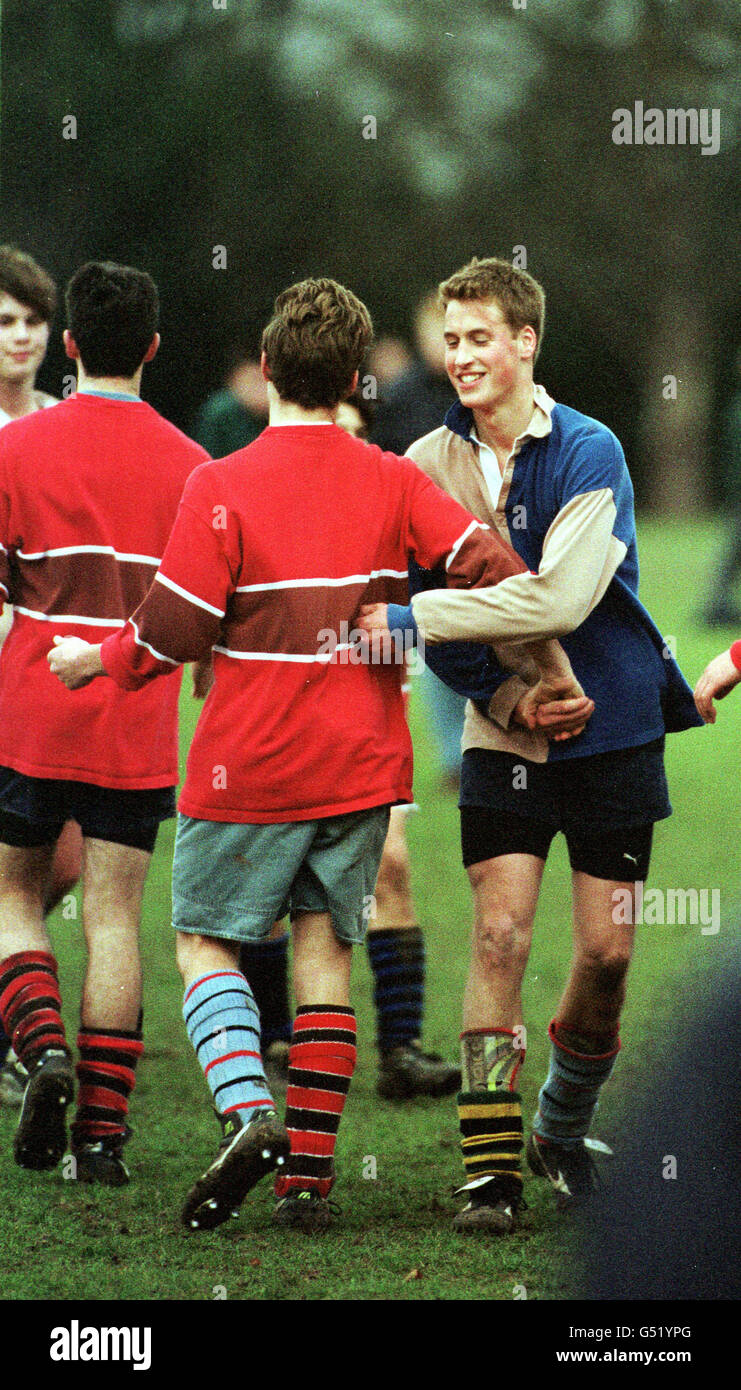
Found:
[0,951,70,1068]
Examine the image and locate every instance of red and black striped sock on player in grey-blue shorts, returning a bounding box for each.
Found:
[275,1004,357,1197]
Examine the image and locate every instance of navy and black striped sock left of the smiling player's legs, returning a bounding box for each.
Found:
[367,927,425,1052]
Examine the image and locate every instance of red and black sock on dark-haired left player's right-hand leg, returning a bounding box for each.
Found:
[71,1027,143,1150]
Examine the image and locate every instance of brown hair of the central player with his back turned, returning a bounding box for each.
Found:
[261,279,373,410]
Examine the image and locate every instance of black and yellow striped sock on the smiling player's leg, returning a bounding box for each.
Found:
[457,1090,523,1187]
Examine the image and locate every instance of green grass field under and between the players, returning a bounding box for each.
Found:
[0,521,741,1301]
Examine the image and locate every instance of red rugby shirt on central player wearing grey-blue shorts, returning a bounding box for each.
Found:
[101,424,526,823]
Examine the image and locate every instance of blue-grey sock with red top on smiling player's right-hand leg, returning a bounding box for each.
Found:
[532,1019,620,1145]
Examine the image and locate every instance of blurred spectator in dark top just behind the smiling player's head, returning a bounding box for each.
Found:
[373,291,466,791]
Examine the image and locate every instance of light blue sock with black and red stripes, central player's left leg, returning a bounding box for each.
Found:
[182,970,275,1120]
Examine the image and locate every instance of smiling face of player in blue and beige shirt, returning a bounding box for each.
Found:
[445,299,537,411]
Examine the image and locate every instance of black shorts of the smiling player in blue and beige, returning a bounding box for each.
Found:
[460,738,671,883]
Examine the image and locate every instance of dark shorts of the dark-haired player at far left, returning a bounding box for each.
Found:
[0,767,175,853]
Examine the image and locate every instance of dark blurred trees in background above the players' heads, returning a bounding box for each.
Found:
[0,0,741,512]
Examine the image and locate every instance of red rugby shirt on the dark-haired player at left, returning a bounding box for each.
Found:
[0,392,209,790]
